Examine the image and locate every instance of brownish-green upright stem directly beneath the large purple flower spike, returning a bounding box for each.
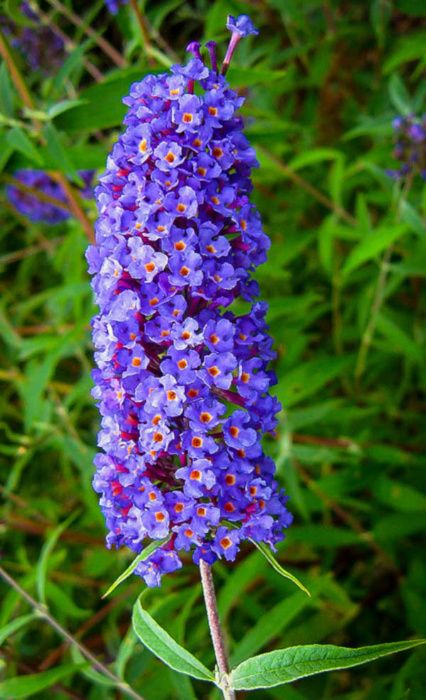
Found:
[200,560,235,700]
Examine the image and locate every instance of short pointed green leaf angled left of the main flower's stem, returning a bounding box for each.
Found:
[132,600,215,683]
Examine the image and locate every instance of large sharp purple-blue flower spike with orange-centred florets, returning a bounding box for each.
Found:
[88,16,291,586]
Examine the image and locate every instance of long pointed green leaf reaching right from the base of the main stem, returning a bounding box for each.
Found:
[231,639,426,690]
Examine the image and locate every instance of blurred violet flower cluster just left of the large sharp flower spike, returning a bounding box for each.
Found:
[6,170,94,224]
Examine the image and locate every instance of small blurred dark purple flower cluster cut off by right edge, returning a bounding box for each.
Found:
[387,115,426,180]
